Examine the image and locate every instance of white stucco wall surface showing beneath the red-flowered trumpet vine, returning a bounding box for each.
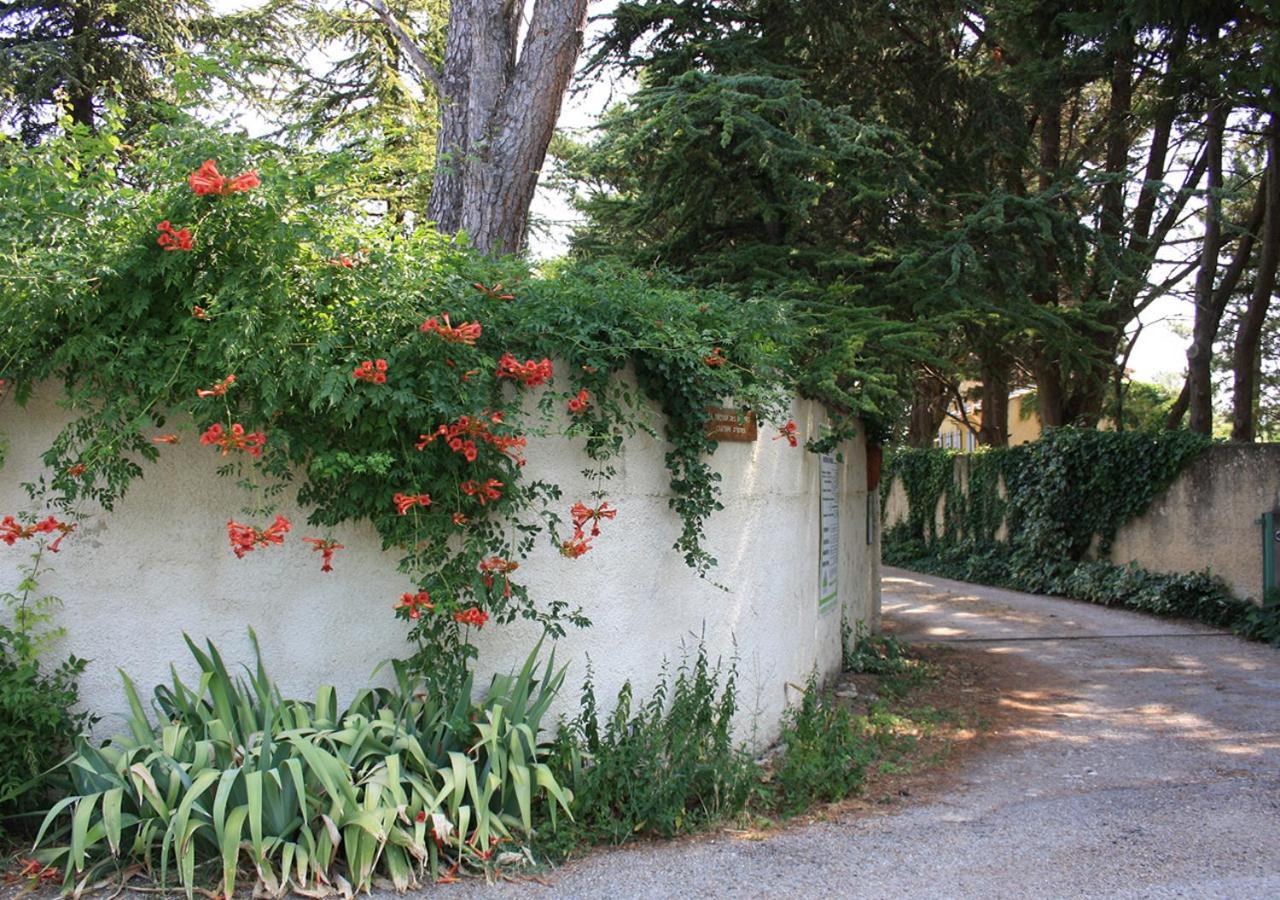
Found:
[0,389,879,740]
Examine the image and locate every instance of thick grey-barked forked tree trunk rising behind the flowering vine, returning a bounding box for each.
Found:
[366,0,588,253]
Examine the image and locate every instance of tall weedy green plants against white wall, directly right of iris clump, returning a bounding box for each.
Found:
[542,645,755,844]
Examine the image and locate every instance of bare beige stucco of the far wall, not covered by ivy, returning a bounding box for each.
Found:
[884,444,1280,600]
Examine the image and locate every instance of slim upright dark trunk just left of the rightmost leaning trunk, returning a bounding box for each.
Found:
[1187,99,1228,434]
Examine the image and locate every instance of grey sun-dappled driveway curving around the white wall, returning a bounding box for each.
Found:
[450,568,1280,897]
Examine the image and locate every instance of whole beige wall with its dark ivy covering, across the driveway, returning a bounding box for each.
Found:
[881,429,1280,640]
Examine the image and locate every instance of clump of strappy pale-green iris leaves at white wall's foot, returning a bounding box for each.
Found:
[37,632,571,897]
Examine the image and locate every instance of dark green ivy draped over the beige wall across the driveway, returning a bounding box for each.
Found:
[881,429,1275,640]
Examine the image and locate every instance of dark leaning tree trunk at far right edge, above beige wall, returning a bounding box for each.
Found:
[1231,114,1280,442]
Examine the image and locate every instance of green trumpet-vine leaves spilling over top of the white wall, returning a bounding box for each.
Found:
[0,124,791,682]
